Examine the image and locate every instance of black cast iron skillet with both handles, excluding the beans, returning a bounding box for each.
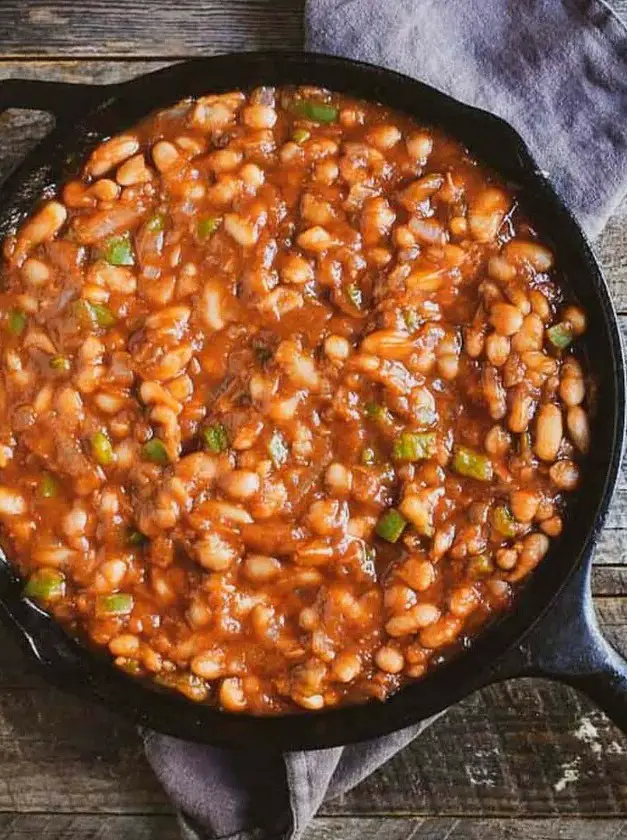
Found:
[0,52,627,750]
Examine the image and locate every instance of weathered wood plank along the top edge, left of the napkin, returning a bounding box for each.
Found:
[0,0,304,58]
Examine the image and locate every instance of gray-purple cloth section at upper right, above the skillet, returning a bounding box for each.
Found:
[307,0,627,236]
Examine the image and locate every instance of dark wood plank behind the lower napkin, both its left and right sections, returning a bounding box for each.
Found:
[0,668,627,817]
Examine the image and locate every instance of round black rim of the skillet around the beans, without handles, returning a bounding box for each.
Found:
[0,51,625,749]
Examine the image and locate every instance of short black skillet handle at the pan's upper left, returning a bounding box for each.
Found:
[0,79,109,120]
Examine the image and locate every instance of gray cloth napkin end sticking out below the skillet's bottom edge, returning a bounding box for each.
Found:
[144,715,437,840]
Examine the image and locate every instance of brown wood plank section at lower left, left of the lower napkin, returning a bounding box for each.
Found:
[0,687,171,813]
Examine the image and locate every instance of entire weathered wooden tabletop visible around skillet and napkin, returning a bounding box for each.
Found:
[0,0,627,840]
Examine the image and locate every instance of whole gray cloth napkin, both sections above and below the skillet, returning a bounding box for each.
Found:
[146,0,627,840]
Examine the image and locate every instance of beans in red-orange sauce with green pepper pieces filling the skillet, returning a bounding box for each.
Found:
[0,88,590,714]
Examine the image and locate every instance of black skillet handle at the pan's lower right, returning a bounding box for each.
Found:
[498,560,627,734]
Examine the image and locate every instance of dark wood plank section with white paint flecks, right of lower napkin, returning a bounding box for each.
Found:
[323,680,627,816]
